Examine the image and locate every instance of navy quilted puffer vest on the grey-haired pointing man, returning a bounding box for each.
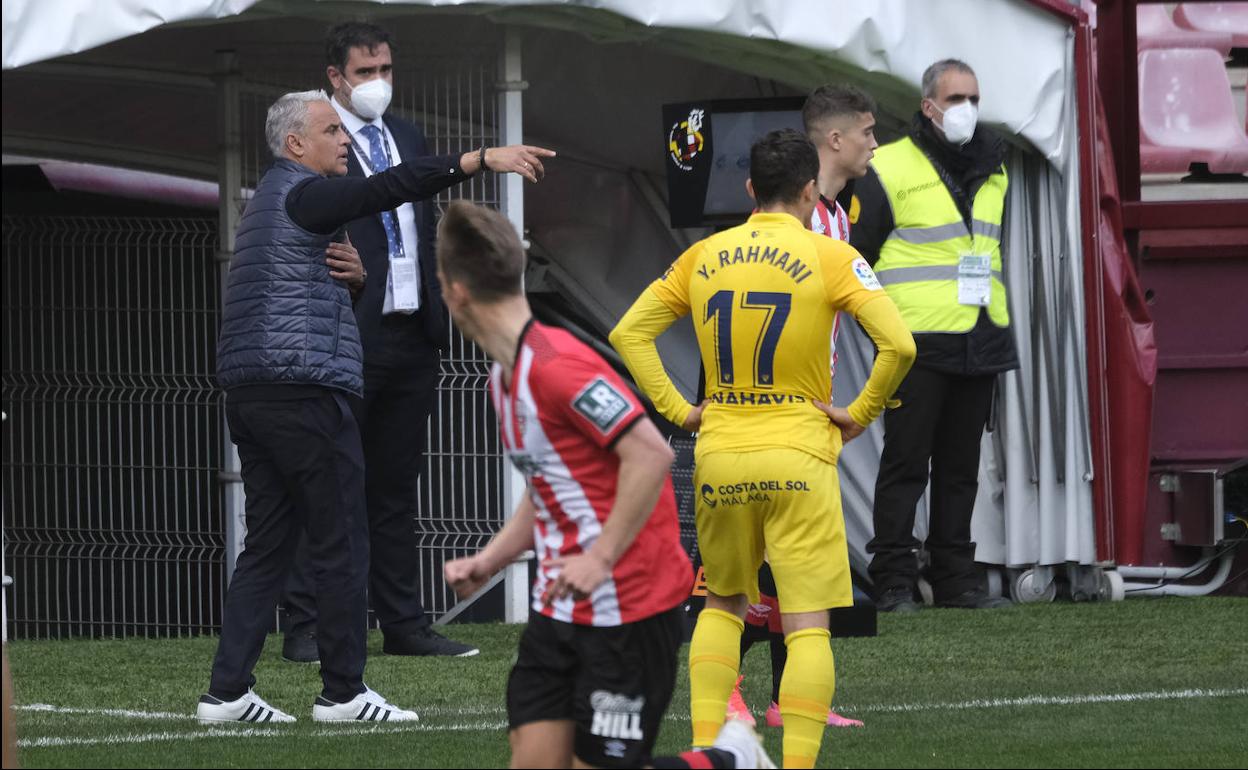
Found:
[217,158,364,396]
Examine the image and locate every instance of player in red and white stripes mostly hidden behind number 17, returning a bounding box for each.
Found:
[728,85,879,728]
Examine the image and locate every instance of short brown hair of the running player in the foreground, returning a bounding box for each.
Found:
[438,201,524,302]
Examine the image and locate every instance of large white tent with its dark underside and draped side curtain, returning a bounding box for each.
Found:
[4,0,1096,594]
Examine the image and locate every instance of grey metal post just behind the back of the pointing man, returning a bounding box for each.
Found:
[216,51,247,583]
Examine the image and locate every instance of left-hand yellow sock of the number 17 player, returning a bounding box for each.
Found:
[689,609,745,748]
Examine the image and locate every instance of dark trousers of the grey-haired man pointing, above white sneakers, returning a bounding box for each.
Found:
[208,388,368,703]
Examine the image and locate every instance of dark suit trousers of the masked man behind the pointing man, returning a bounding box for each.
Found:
[286,337,441,636]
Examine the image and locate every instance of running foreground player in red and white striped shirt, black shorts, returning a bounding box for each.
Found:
[438,202,774,768]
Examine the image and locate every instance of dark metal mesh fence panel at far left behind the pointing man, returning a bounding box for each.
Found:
[2,216,223,636]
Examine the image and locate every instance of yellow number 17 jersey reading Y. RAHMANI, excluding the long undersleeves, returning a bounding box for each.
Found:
[650,213,885,462]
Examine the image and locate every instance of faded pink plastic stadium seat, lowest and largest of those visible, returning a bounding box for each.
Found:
[1139,49,1248,173]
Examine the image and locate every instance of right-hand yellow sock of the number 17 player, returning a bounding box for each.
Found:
[780,628,836,768]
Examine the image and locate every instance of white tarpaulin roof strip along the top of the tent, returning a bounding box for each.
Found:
[4,0,1073,160]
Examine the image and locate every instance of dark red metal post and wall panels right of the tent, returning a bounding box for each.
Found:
[1073,0,1248,565]
